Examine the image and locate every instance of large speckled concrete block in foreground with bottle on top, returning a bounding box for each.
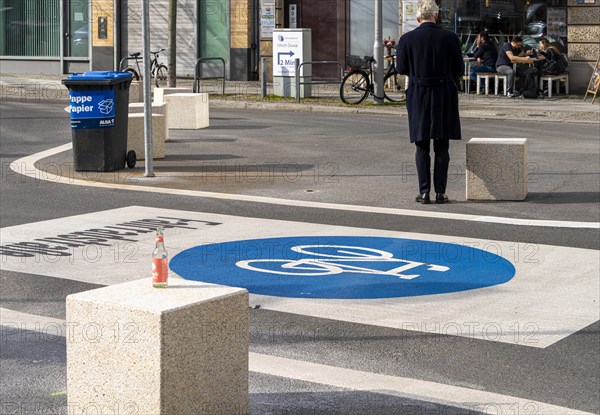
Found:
[66,278,249,415]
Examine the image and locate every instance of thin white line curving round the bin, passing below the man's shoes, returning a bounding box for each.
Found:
[10,143,600,229]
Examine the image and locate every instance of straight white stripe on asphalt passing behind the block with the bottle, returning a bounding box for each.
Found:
[0,308,590,415]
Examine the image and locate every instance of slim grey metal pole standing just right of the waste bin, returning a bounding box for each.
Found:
[142,0,154,177]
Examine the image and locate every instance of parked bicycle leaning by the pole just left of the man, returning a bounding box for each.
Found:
[340,45,405,104]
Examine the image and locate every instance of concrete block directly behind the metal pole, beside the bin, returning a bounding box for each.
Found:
[127,113,166,160]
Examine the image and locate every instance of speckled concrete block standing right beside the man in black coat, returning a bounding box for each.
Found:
[467,138,527,200]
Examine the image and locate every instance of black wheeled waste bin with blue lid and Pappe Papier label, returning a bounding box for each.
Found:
[62,71,135,171]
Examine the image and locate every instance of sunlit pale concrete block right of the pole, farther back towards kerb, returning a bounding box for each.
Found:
[165,93,209,130]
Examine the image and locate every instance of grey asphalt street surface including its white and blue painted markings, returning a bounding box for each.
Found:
[0,101,600,414]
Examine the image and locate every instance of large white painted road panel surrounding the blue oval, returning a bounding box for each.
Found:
[0,206,600,348]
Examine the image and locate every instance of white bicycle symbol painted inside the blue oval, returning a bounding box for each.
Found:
[236,245,449,280]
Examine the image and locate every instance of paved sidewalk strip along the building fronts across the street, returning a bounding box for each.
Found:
[0,73,600,123]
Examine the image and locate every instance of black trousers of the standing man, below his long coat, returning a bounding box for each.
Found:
[415,140,450,194]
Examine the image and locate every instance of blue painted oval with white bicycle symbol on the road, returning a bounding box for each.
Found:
[170,236,515,299]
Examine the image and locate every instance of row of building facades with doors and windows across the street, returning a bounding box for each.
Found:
[0,0,600,92]
